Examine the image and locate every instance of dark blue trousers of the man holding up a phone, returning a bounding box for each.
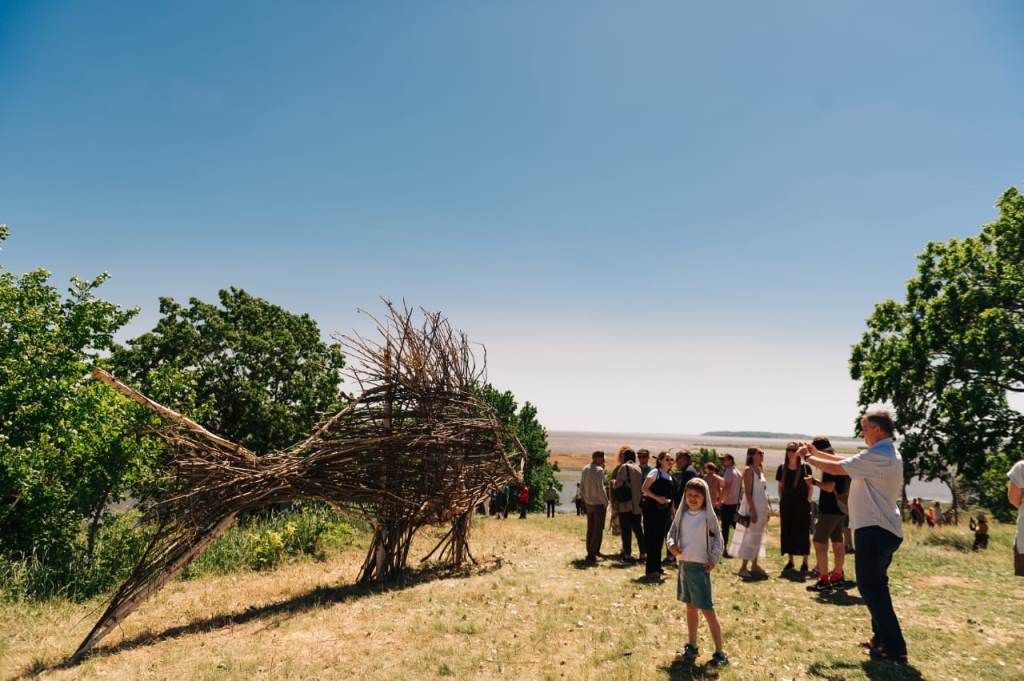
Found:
[853,525,906,655]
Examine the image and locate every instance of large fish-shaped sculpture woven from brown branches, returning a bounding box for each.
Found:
[72,301,525,661]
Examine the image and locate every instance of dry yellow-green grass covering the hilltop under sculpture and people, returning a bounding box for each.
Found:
[0,515,1024,681]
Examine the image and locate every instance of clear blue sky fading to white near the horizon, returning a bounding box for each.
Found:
[0,0,1024,433]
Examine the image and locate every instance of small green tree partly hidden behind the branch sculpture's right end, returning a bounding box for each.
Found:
[482,384,562,511]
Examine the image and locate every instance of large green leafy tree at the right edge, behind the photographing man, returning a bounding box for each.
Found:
[850,188,1024,516]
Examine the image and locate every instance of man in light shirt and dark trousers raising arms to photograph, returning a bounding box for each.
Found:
[799,410,906,663]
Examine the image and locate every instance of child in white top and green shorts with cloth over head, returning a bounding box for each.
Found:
[666,477,729,667]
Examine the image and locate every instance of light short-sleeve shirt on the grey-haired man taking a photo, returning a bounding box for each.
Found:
[839,437,903,538]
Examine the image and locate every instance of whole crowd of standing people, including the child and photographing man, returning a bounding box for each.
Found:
[575,411,906,667]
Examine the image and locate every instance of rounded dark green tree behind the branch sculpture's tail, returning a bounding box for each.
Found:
[113,288,345,454]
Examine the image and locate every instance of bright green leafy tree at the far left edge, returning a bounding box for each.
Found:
[0,225,154,569]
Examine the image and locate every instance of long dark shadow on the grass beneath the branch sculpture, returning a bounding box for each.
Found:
[8,558,502,681]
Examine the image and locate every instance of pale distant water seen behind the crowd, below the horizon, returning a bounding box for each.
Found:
[548,430,952,513]
